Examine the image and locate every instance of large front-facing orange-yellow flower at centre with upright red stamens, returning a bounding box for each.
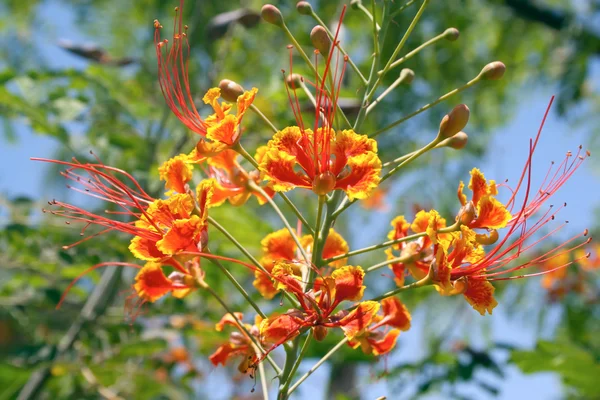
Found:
[260,13,381,200]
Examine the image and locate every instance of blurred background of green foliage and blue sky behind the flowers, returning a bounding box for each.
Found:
[0,0,600,400]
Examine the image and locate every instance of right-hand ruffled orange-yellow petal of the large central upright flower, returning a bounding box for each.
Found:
[335,152,381,200]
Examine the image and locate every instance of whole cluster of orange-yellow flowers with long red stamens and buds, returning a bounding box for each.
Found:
[36,0,598,398]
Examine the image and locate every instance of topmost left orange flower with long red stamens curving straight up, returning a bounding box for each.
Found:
[154,0,258,159]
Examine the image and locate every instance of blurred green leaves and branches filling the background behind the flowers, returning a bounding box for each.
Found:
[0,0,600,399]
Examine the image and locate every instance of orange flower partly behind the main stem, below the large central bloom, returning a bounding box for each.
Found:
[253,229,348,299]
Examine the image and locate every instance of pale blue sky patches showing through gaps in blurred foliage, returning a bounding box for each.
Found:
[0,2,600,400]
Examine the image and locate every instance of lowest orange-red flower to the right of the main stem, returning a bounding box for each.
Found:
[340,297,411,356]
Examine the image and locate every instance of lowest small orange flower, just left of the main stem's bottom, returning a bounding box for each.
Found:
[209,312,261,374]
